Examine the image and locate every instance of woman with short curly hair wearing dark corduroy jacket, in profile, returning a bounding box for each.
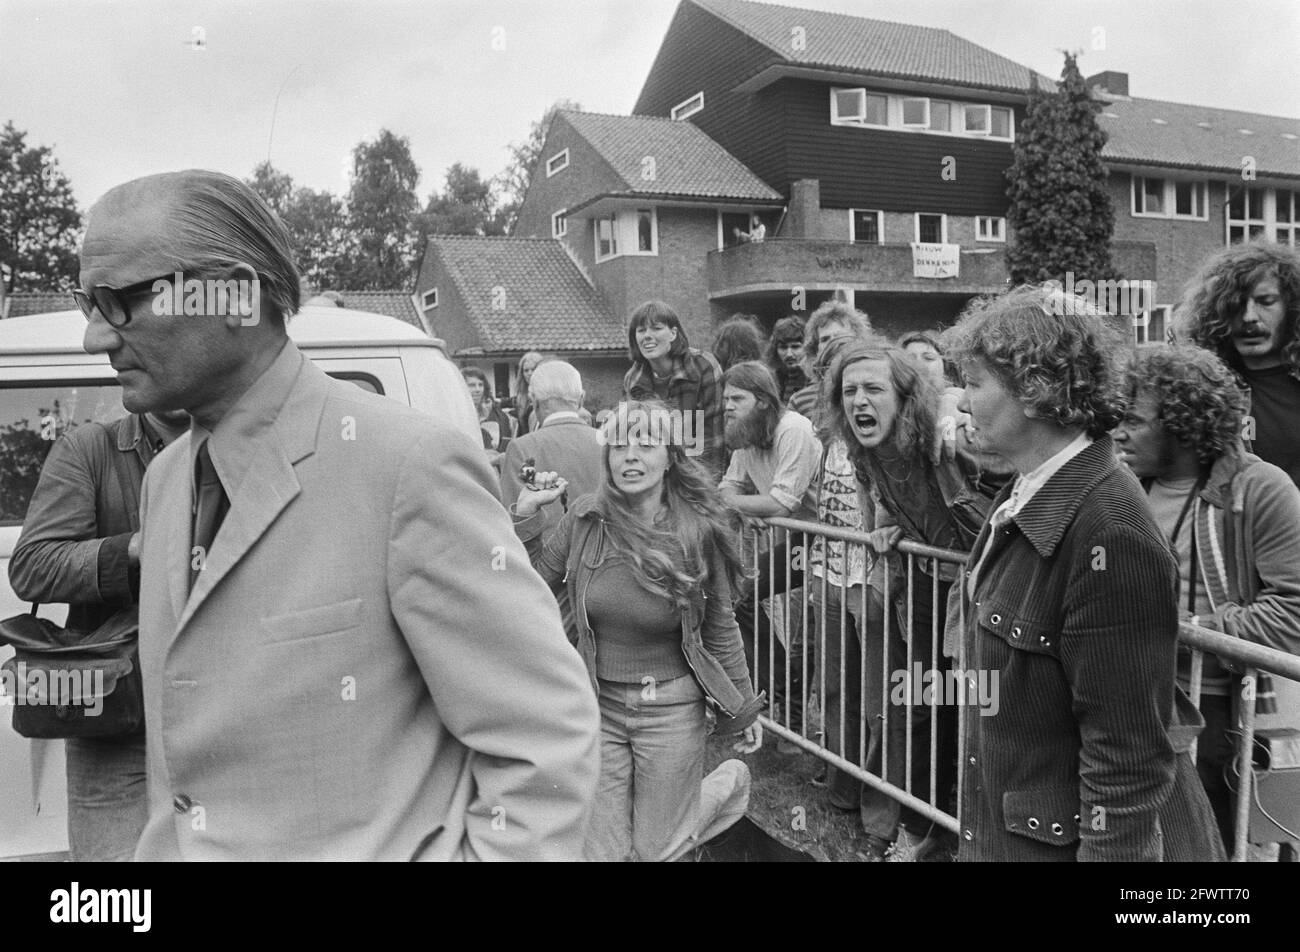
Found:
[944,287,1223,861]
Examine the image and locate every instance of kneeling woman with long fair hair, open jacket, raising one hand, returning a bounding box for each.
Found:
[514,402,763,861]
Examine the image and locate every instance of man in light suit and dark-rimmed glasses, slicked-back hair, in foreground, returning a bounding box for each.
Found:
[77,172,599,860]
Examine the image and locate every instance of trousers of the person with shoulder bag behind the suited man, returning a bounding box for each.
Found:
[64,731,150,862]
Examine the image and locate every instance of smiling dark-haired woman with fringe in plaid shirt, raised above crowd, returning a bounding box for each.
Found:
[623,300,727,481]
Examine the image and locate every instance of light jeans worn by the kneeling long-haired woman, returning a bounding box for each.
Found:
[584,675,749,862]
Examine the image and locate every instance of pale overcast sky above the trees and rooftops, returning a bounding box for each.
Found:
[0,0,1300,207]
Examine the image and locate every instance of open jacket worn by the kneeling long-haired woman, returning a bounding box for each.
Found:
[515,494,764,734]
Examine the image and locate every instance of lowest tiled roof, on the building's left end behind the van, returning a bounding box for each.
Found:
[429,235,628,354]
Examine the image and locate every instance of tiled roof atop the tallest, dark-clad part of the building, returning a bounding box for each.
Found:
[689,0,1052,92]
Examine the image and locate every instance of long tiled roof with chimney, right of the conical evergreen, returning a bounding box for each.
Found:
[1097,99,1300,176]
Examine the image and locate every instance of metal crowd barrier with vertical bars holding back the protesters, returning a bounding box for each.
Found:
[742,519,1300,862]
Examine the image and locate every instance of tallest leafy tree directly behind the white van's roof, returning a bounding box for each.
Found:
[345,129,420,290]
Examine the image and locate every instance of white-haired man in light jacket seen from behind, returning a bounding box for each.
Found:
[501,360,602,524]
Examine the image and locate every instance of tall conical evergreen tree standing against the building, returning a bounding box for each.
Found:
[1006,53,1117,284]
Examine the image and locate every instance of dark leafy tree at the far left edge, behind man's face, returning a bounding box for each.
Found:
[0,122,82,291]
